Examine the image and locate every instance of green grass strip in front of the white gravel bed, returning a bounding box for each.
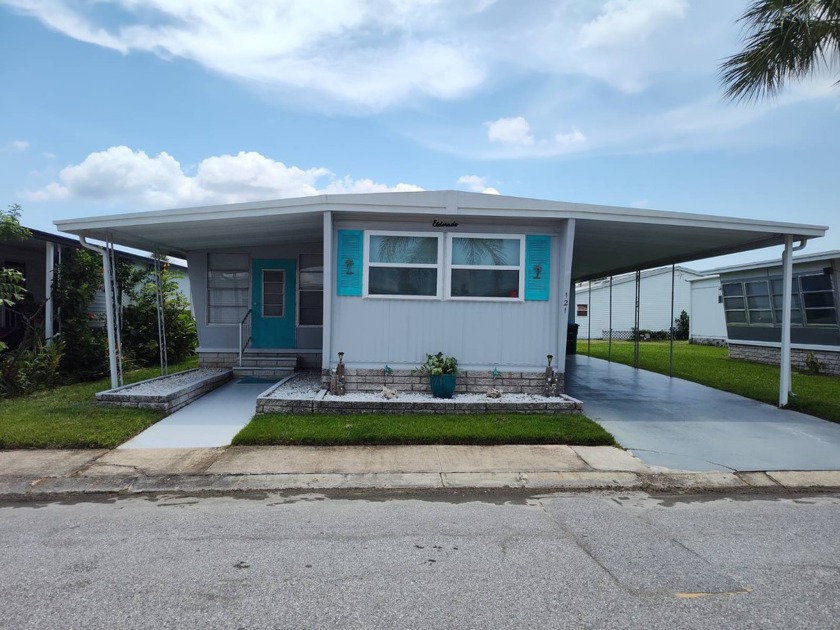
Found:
[232,414,616,446]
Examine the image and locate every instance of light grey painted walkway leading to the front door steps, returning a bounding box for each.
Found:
[119,379,271,449]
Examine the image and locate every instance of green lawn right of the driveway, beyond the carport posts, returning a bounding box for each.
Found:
[577,340,840,422]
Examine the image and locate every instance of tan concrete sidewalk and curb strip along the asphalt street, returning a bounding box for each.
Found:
[0,445,840,500]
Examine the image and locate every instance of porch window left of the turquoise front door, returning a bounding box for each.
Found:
[207,254,251,324]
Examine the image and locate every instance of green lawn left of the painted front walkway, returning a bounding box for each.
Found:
[0,358,198,449]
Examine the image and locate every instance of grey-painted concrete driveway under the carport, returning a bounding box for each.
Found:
[566,355,840,471]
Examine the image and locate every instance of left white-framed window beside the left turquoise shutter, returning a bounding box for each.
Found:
[365,232,441,297]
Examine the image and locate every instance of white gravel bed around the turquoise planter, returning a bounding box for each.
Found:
[268,373,558,403]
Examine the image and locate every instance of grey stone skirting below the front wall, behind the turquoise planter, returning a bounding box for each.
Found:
[321,367,565,394]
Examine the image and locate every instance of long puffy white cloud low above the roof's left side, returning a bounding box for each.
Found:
[27,146,422,208]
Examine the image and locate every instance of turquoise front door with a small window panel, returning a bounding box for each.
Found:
[251,258,297,348]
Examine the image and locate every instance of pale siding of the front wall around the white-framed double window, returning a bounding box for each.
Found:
[330,217,571,370]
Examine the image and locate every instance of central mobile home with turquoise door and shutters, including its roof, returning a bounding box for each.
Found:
[56,191,826,400]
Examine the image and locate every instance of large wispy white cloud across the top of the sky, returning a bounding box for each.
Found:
[0,0,704,109]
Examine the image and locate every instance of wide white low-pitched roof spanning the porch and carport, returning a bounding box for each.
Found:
[55,191,828,281]
